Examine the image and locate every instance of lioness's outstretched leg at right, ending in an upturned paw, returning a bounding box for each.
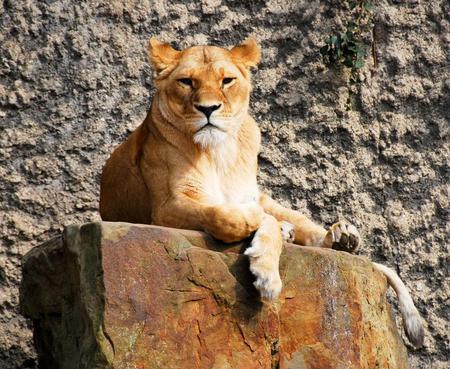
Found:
[259,193,360,252]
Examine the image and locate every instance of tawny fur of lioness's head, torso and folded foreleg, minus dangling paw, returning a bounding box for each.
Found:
[100,39,263,231]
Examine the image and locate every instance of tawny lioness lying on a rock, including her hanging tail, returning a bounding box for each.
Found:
[100,38,423,346]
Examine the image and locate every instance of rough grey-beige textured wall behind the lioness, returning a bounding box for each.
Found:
[0,0,450,369]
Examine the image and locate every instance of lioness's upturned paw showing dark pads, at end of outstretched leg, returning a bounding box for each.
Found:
[323,221,360,253]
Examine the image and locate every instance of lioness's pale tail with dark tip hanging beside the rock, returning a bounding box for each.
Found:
[373,263,424,348]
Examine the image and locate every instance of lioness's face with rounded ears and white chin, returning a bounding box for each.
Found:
[150,39,259,148]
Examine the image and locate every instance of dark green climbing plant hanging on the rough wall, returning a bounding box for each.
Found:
[320,0,373,110]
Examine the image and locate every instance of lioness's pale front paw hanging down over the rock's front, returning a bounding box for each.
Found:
[244,233,282,300]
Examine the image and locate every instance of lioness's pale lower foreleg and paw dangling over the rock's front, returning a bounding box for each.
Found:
[244,214,283,300]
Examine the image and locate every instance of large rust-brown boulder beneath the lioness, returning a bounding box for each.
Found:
[21,223,407,369]
